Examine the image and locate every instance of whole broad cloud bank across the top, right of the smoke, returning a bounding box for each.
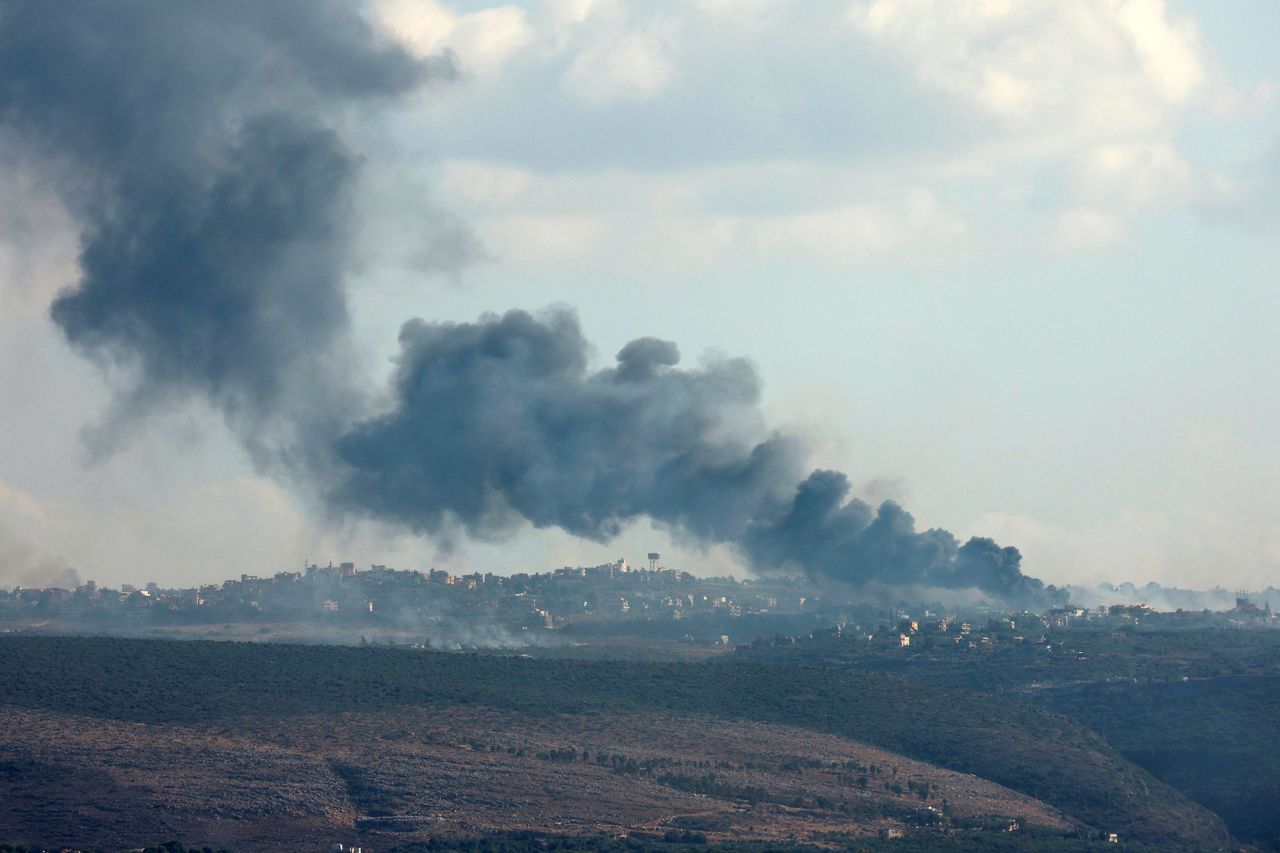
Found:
[375,0,1230,265]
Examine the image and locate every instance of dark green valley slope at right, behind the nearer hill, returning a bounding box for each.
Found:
[739,625,1280,850]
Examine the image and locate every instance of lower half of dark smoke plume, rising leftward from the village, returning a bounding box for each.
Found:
[335,310,1052,603]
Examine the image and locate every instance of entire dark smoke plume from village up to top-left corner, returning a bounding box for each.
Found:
[0,0,1044,601]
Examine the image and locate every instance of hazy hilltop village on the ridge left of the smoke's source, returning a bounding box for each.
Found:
[0,555,831,646]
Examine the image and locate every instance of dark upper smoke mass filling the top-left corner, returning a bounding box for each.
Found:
[0,0,448,462]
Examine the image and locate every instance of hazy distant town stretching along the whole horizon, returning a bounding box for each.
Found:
[0,553,1280,648]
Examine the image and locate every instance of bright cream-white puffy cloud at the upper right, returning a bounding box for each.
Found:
[850,0,1213,245]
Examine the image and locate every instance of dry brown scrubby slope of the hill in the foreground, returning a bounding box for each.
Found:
[0,707,1071,850]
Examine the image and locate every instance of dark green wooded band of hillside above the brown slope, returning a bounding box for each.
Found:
[0,637,1229,847]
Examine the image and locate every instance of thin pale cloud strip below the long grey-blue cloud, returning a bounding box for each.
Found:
[427,160,966,273]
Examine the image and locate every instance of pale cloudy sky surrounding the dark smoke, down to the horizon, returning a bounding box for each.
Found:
[0,0,1280,588]
